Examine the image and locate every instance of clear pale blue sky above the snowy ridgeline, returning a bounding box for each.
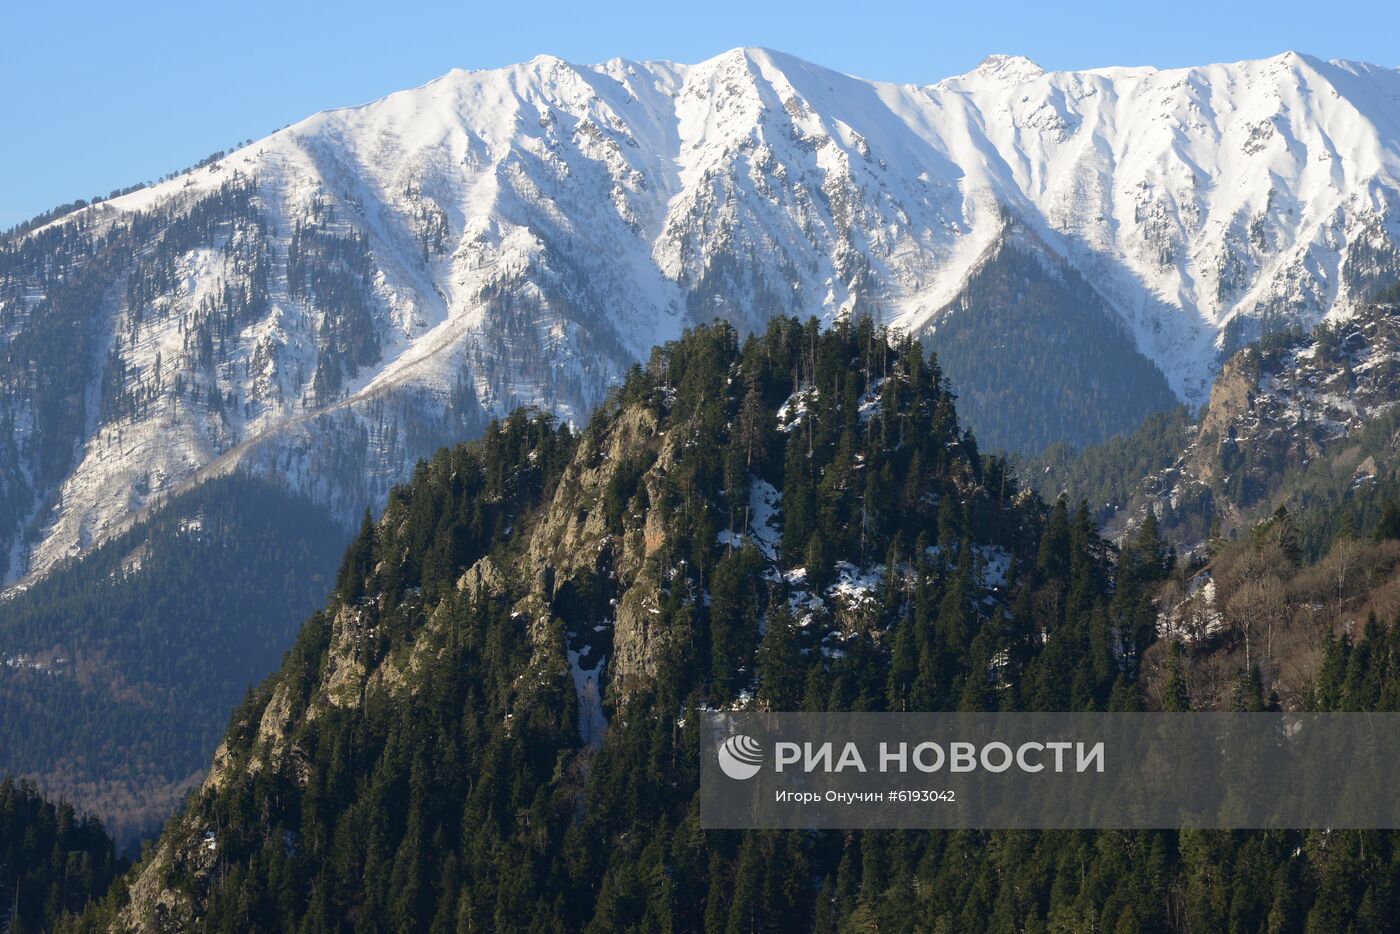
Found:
[0,0,1400,228]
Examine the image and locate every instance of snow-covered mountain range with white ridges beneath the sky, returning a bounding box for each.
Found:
[0,49,1400,580]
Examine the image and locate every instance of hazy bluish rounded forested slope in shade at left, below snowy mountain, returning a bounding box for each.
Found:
[0,475,351,840]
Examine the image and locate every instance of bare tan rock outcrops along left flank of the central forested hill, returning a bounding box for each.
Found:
[112,406,690,931]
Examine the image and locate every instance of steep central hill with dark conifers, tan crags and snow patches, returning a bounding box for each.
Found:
[76,319,1400,931]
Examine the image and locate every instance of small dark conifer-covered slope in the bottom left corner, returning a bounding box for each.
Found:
[0,779,126,934]
